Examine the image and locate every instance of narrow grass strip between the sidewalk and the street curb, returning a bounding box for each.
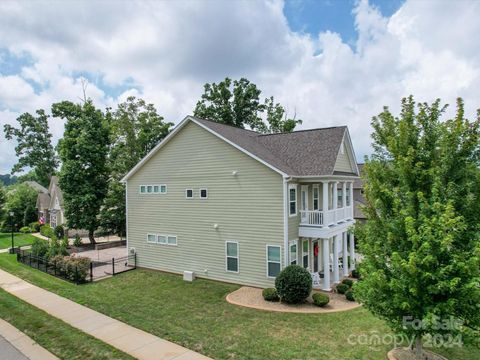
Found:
[0,289,133,360]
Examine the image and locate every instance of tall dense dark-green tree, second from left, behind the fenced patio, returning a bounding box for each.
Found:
[52,100,109,243]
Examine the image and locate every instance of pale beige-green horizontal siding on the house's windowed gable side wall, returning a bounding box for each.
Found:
[127,123,284,286]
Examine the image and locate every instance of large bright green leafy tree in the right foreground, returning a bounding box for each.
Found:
[355,96,480,356]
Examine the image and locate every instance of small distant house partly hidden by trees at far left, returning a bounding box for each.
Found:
[36,176,65,227]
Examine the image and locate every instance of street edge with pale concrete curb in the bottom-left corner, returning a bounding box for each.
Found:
[0,319,58,360]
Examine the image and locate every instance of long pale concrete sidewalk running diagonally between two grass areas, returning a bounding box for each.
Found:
[0,270,209,360]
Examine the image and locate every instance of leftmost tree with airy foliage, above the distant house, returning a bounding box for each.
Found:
[4,109,58,186]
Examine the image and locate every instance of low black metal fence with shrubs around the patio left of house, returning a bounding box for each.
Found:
[16,249,137,284]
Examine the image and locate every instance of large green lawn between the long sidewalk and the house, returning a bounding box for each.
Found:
[0,254,480,360]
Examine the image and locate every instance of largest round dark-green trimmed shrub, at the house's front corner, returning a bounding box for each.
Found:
[275,265,312,304]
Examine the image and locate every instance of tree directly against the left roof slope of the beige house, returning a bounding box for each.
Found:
[100,96,173,235]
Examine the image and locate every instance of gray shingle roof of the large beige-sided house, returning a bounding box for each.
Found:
[194,118,354,176]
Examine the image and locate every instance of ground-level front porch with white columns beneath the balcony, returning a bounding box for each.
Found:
[290,230,356,291]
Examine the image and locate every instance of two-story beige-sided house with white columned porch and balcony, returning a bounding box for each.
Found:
[122,116,358,290]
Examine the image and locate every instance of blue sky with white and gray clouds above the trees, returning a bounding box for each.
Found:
[0,0,480,174]
